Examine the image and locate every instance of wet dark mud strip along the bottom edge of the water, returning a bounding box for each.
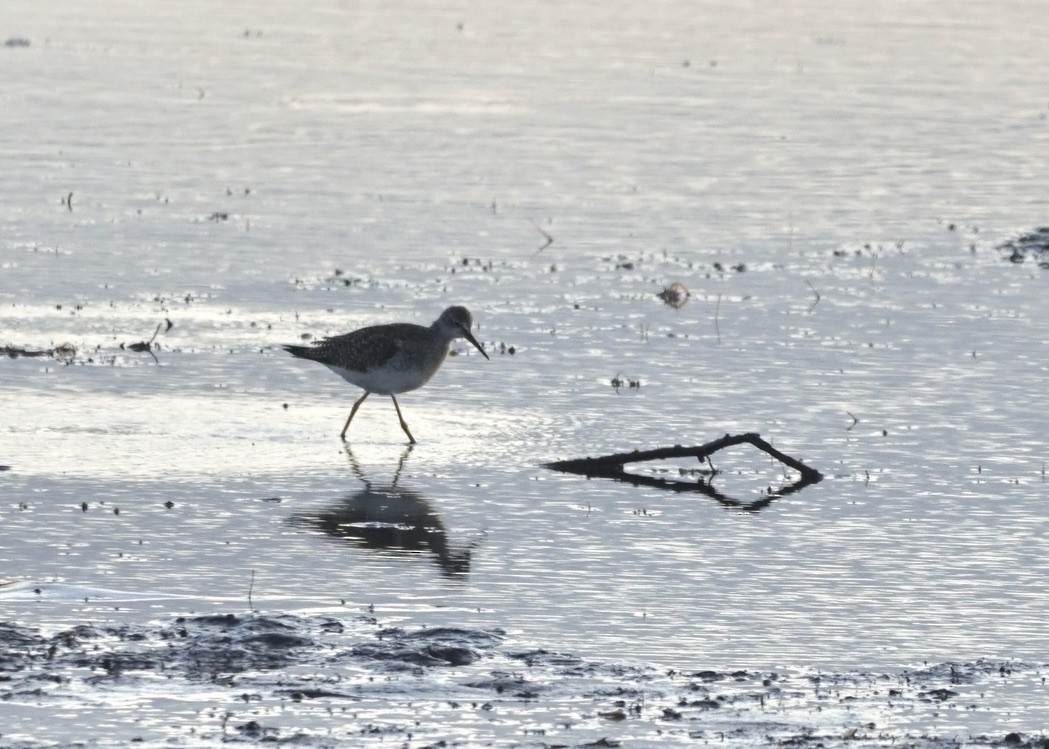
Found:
[0,615,1049,748]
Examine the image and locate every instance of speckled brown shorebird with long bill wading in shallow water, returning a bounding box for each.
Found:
[284,306,488,445]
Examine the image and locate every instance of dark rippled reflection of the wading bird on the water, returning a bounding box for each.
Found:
[288,445,475,578]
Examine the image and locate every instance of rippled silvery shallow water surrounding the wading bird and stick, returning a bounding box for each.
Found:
[0,2,1049,739]
